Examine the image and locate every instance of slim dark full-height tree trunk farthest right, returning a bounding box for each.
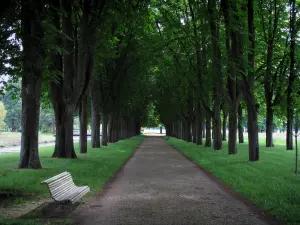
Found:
[286,0,296,150]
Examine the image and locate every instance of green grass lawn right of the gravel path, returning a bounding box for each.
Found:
[167,135,300,225]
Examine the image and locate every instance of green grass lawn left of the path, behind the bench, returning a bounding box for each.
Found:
[0,136,143,224]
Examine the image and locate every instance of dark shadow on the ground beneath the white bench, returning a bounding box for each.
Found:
[21,202,80,219]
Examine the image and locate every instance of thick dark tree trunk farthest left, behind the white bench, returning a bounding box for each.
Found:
[19,0,44,169]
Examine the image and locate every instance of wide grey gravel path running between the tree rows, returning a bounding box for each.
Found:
[76,137,274,225]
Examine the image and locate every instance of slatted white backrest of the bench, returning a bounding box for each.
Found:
[42,172,76,200]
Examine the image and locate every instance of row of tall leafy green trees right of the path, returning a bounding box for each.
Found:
[150,0,300,161]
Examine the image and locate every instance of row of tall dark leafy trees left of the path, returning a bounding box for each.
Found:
[1,0,155,168]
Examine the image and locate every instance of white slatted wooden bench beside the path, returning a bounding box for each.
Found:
[41,172,90,203]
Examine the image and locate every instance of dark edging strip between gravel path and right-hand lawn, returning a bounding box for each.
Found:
[162,138,287,225]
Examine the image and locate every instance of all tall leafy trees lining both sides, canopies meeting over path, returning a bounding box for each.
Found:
[0,0,300,168]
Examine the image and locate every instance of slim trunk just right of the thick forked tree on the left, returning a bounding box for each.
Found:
[79,96,88,153]
